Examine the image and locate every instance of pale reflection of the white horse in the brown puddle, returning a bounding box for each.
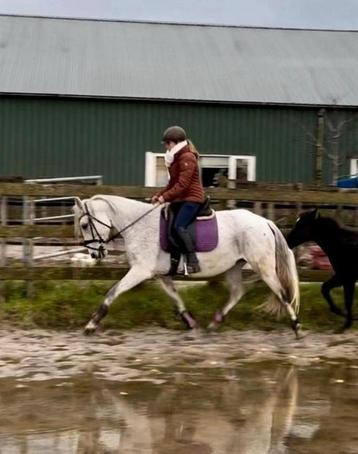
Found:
[144,366,299,454]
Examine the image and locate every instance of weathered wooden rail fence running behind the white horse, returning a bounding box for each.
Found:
[0,183,358,281]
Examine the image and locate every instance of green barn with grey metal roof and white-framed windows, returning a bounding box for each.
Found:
[0,16,358,186]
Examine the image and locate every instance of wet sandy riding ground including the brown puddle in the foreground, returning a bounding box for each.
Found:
[0,329,358,454]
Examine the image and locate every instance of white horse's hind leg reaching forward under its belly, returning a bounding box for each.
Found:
[208,262,245,329]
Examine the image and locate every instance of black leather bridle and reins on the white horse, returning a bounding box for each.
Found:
[78,203,160,259]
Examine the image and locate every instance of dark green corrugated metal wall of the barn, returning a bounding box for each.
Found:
[0,96,357,185]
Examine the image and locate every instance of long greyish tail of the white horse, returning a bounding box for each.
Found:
[261,221,300,317]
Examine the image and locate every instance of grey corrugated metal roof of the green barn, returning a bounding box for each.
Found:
[0,16,358,106]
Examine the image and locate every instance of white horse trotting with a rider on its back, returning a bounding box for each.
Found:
[74,195,300,337]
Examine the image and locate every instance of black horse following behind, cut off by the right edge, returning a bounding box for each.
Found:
[287,210,358,330]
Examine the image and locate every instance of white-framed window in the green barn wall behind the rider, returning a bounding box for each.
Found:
[145,151,256,187]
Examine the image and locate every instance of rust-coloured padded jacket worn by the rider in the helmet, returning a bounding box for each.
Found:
[157,146,205,203]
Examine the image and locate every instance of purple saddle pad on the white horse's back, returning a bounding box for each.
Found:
[160,212,219,252]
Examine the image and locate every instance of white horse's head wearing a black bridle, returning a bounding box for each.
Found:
[73,197,112,260]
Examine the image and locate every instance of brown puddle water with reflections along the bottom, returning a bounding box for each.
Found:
[0,363,358,454]
